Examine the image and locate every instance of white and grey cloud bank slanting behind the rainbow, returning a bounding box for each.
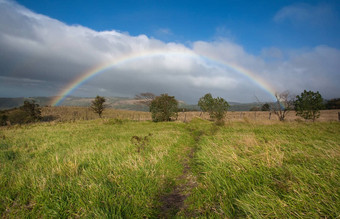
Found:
[0,0,340,103]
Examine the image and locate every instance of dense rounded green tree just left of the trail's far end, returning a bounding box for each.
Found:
[150,94,178,122]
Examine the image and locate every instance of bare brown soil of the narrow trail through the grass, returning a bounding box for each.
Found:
[160,147,197,218]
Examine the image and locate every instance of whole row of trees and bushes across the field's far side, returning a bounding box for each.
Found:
[0,90,340,126]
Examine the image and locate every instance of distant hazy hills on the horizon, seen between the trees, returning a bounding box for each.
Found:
[0,96,261,111]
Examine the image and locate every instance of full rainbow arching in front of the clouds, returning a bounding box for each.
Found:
[50,50,275,106]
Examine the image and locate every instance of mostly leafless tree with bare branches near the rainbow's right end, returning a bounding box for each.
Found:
[271,91,294,121]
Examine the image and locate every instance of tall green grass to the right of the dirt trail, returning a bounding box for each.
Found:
[187,123,340,218]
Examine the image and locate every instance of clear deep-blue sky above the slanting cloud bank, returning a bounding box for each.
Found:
[18,0,340,54]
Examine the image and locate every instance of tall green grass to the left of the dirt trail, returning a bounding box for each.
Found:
[0,120,186,218]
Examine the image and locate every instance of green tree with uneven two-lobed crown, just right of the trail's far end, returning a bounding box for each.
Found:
[198,93,229,124]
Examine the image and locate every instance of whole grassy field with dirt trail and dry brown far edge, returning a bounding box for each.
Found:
[0,108,340,218]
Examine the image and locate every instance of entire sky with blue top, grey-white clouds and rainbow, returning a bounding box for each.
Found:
[0,0,340,103]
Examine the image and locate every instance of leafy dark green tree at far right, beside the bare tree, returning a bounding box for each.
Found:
[294,90,324,122]
